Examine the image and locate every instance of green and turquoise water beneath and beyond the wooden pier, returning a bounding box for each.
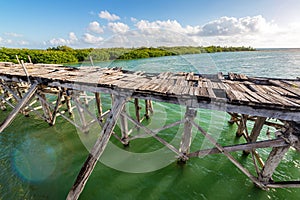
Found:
[0,51,300,200]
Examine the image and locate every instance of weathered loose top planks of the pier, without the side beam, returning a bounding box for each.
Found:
[0,64,300,110]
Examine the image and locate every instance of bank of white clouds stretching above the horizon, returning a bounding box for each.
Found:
[0,10,300,48]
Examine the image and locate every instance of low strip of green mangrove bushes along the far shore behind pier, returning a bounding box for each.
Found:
[0,46,256,64]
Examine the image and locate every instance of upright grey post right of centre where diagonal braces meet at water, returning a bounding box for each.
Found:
[179,107,197,162]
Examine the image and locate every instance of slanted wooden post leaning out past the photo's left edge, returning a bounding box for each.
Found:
[0,83,38,133]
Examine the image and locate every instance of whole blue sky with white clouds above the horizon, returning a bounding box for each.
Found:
[0,0,300,48]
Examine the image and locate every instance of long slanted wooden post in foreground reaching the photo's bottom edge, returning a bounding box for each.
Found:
[67,97,126,200]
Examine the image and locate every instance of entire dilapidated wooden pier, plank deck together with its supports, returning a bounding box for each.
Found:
[0,63,300,199]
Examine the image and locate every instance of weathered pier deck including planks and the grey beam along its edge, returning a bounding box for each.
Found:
[0,63,300,121]
